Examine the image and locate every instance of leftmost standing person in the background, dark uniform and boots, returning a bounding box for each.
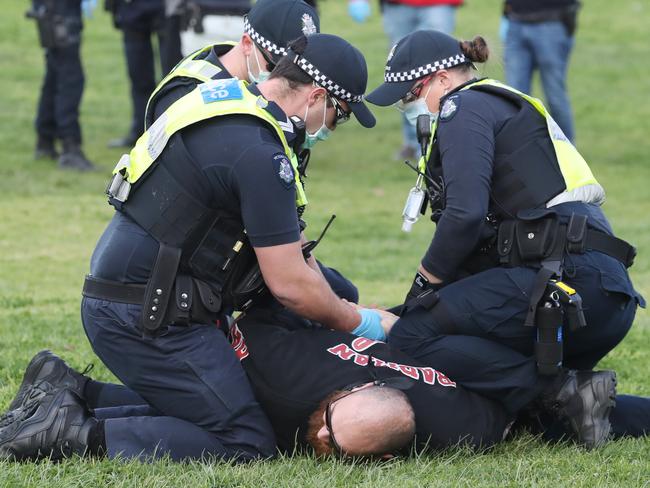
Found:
[27,0,94,171]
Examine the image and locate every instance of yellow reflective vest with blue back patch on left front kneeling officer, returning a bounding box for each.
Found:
[113,78,307,207]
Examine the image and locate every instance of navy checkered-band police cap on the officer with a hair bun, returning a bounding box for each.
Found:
[366,30,471,106]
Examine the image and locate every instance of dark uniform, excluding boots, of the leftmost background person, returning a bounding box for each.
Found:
[32,0,84,146]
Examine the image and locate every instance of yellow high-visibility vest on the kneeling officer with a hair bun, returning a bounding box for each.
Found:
[418,79,600,196]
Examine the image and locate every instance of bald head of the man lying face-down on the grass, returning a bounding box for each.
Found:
[310,386,415,456]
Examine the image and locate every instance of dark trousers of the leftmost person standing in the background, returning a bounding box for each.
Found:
[35,43,84,144]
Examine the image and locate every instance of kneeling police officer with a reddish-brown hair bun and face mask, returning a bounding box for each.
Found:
[368,31,643,446]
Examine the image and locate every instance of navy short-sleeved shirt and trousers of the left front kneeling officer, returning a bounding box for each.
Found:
[82,78,300,459]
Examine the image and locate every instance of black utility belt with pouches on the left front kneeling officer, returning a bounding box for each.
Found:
[82,275,222,333]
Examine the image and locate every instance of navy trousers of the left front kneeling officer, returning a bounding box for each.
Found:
[81,298,275,461]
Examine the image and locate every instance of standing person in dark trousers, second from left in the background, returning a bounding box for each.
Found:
[106,0,180,147]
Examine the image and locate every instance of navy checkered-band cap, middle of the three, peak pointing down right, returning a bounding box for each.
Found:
[288,34,375,127]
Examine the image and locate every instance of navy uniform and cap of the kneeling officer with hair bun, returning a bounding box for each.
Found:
[368,31,643,418]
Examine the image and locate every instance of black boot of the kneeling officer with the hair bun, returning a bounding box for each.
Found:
[542,370,616,449]
